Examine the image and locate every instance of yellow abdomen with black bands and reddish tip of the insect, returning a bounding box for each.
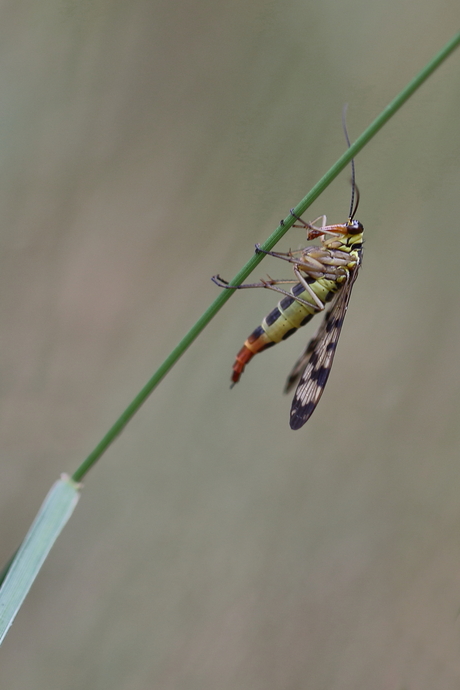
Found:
[232,278,340,383]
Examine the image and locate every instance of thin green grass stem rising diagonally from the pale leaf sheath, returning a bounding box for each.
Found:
[72,32,460,482]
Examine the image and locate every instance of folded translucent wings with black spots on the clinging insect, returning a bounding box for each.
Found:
[284,271,358,429]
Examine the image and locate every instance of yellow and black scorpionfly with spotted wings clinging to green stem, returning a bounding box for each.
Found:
[213,208,364,429]
